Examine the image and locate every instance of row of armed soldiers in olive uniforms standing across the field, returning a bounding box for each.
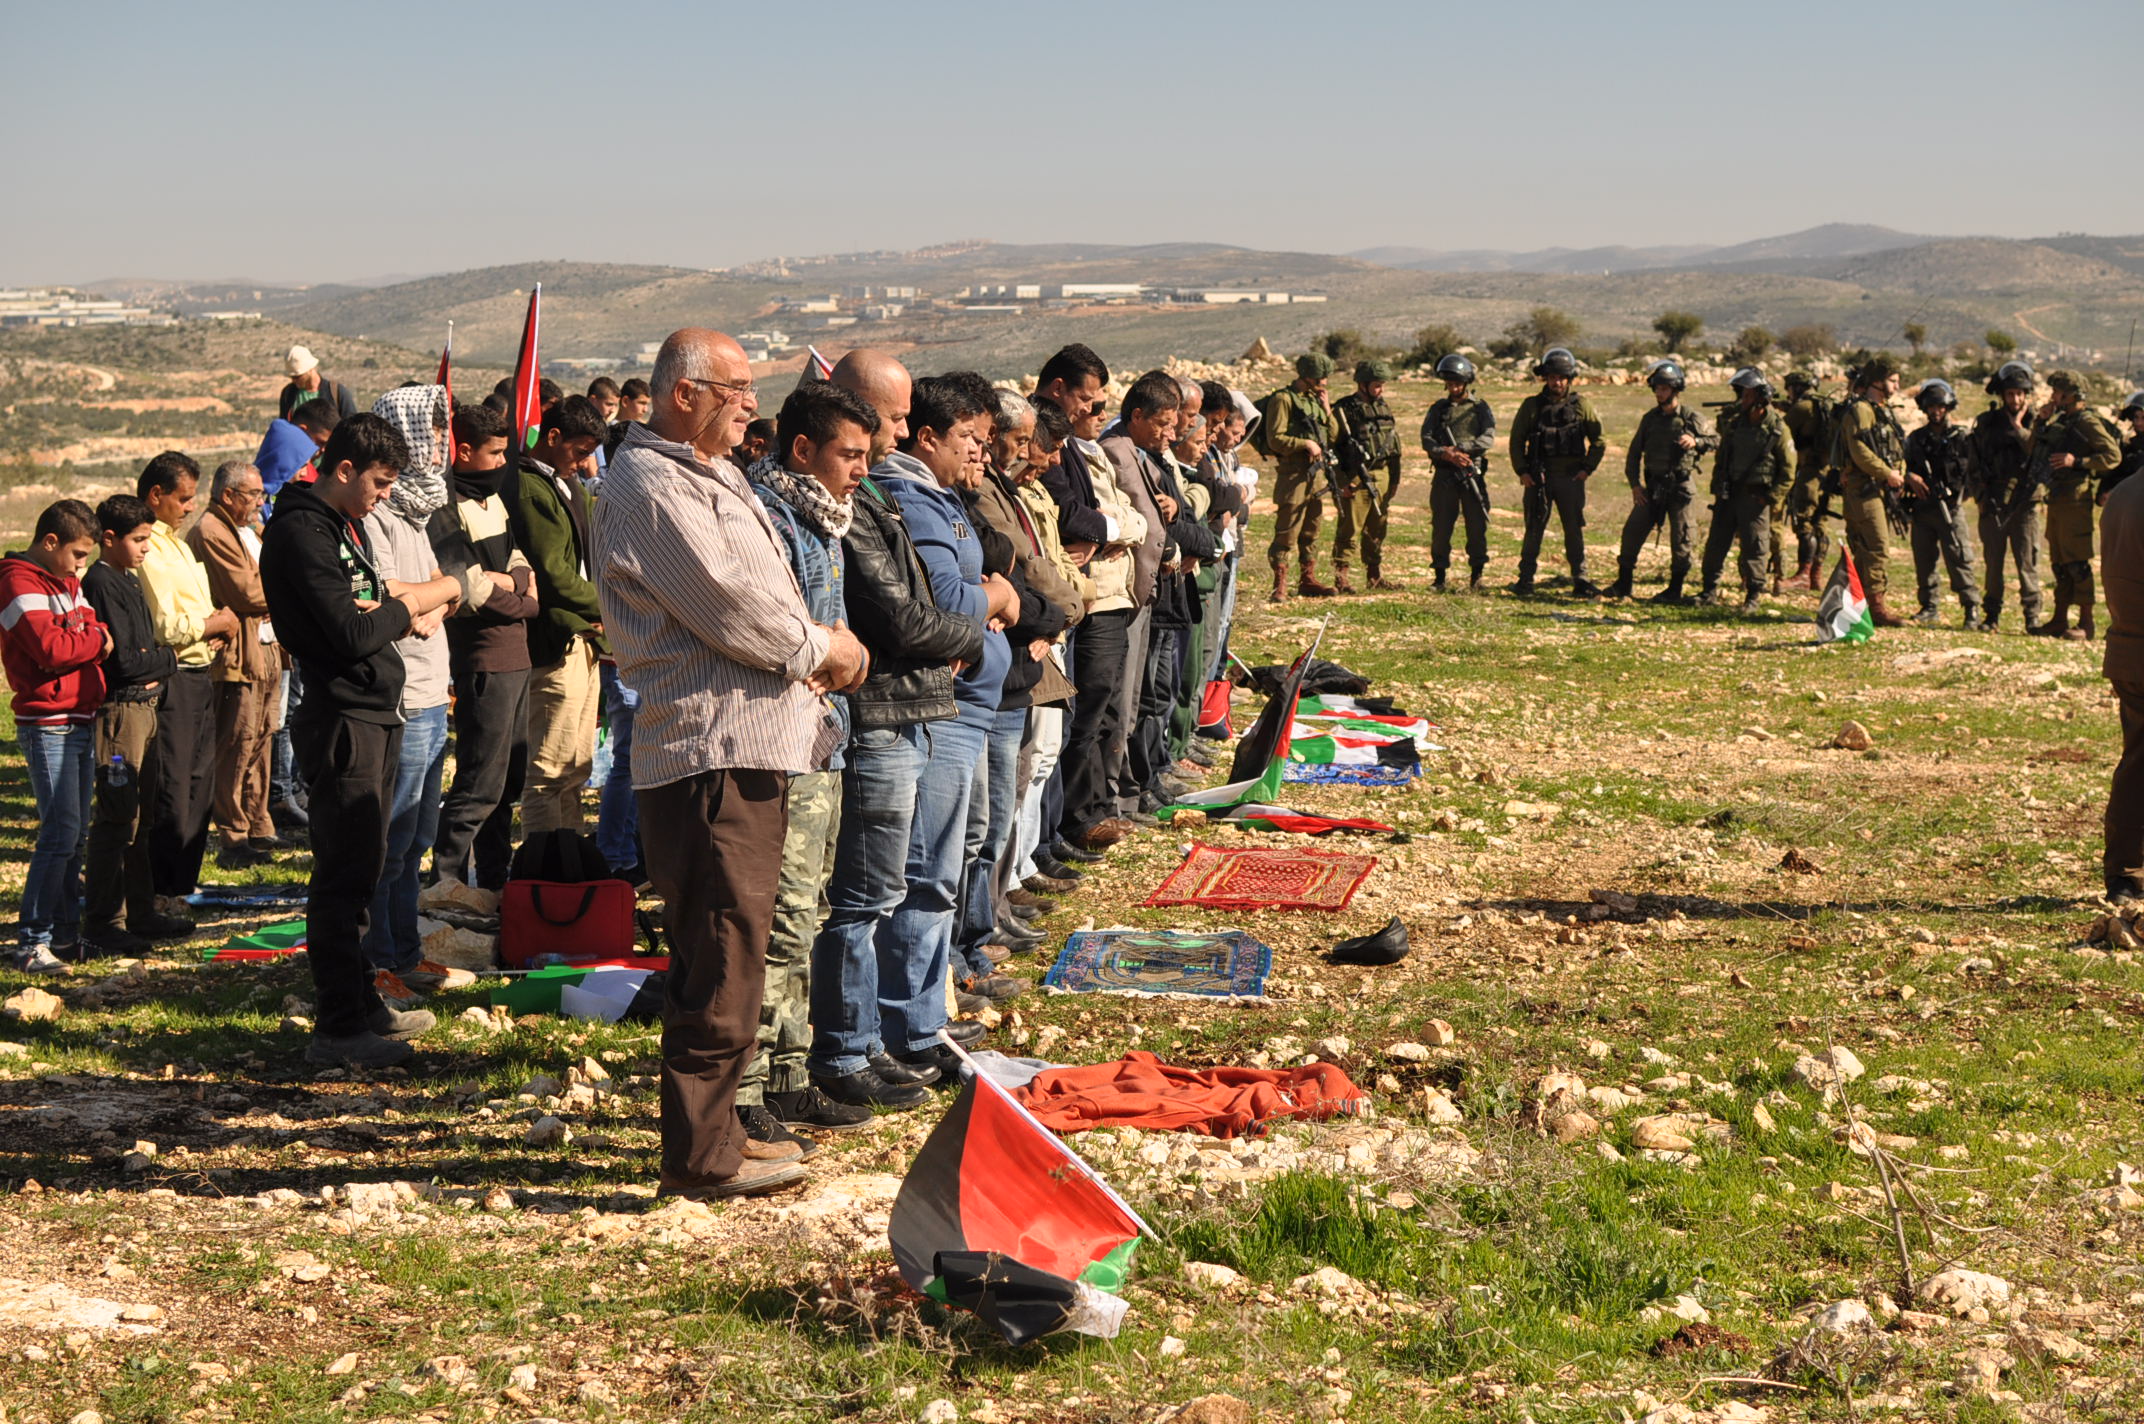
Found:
[1254,347,2144,637]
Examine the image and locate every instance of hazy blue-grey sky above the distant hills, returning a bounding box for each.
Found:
[0,0,2144,281]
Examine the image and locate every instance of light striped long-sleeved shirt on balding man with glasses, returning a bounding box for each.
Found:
[592,425,838,789]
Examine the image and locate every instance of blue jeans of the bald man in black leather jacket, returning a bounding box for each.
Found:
[806,723,926,1077]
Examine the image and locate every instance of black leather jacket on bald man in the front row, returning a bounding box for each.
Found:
[840,480,982,729]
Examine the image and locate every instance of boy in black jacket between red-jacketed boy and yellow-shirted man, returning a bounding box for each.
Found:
[81,497,188,956]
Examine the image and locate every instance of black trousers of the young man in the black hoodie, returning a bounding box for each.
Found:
[292,699,401,1038]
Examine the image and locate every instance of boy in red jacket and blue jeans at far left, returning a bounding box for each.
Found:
[0,500,111,974]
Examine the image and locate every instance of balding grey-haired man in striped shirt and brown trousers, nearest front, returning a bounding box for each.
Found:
[590,328,868,1199]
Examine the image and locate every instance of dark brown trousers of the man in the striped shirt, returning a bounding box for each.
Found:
[637,770,789,1186]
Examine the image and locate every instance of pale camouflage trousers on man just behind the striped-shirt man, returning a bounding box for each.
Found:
[738,772,840,1107]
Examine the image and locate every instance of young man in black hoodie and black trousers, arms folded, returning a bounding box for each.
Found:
[262,412,461,1068]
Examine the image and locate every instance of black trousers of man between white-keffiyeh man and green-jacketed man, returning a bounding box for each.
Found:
[431,667,530,890]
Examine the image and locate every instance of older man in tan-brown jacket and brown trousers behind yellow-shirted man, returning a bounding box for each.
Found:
[187,459,289,866]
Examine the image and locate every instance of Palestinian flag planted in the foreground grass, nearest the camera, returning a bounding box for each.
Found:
[888,1040,1151,1345]
